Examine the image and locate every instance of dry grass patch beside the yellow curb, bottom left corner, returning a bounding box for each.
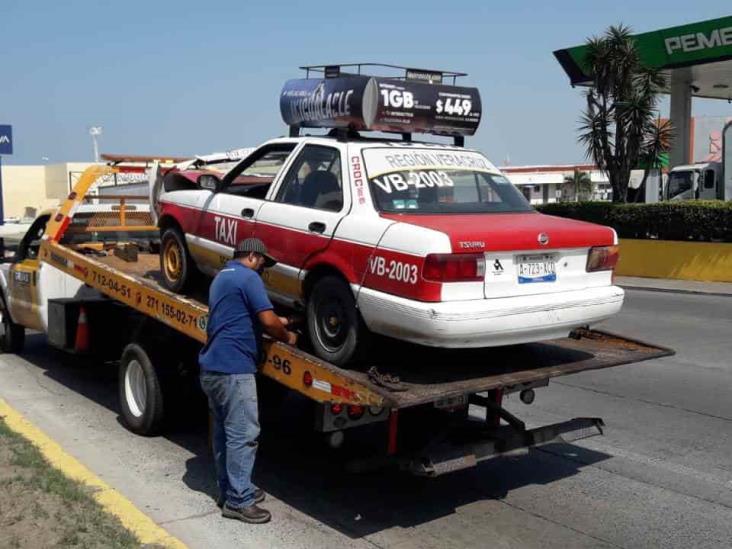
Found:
[0,418,146,549]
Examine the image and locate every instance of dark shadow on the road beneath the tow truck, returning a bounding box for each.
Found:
[15,336,611,538]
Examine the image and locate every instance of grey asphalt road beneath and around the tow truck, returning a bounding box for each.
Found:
[0,291,732,548]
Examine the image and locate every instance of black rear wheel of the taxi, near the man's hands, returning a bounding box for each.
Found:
[307,276,369,366]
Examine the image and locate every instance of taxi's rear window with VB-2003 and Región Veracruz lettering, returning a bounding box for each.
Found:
[364,148,532,213]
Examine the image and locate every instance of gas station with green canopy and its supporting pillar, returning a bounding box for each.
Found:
[554,16,732,169]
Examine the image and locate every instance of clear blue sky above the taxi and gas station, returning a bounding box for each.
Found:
[0,0,732,165]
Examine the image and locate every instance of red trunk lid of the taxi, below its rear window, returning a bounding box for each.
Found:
[381,212,615,252]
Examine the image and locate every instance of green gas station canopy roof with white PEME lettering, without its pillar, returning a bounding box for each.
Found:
[554,16,732,99]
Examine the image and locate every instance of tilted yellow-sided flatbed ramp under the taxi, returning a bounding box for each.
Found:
[41,241,672,409]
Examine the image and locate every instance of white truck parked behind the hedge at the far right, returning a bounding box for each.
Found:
[663,122,732,200]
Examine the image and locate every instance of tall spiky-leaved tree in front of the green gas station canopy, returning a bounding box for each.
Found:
[579,25,671,202]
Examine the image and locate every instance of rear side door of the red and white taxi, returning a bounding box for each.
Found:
[254,144,351,302]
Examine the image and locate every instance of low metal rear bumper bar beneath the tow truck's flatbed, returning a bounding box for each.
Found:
[406,418,605,477]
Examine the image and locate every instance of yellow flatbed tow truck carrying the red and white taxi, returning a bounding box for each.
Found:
[2,157,673,476]
